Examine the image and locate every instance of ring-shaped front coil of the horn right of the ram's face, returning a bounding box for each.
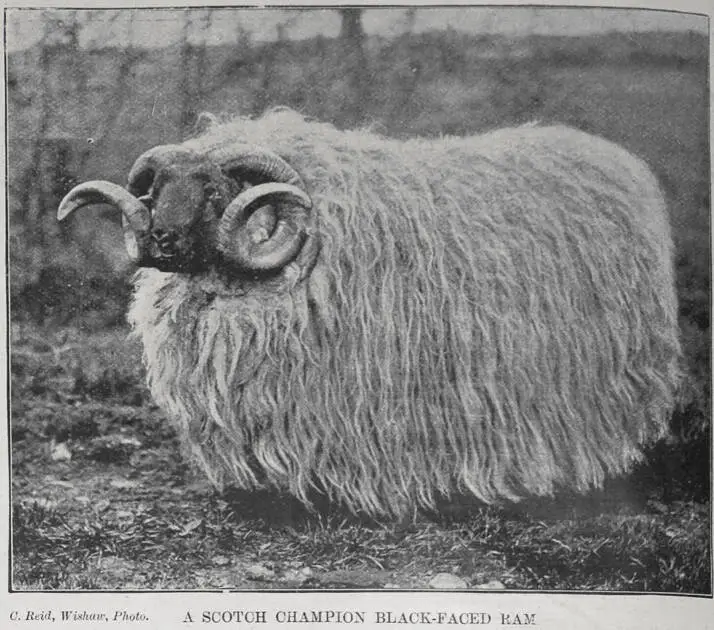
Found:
[218,182,312,271]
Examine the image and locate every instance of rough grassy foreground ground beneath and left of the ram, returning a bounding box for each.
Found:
[11,324,711,593]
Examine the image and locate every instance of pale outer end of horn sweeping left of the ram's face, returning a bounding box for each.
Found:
[57,181,151,261]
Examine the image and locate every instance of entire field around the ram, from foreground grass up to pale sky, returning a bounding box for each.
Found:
[7,10,711,593]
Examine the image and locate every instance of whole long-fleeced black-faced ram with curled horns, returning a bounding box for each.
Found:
[59,109,680,518]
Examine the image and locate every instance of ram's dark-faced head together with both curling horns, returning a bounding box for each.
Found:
[57,145,317,274]
